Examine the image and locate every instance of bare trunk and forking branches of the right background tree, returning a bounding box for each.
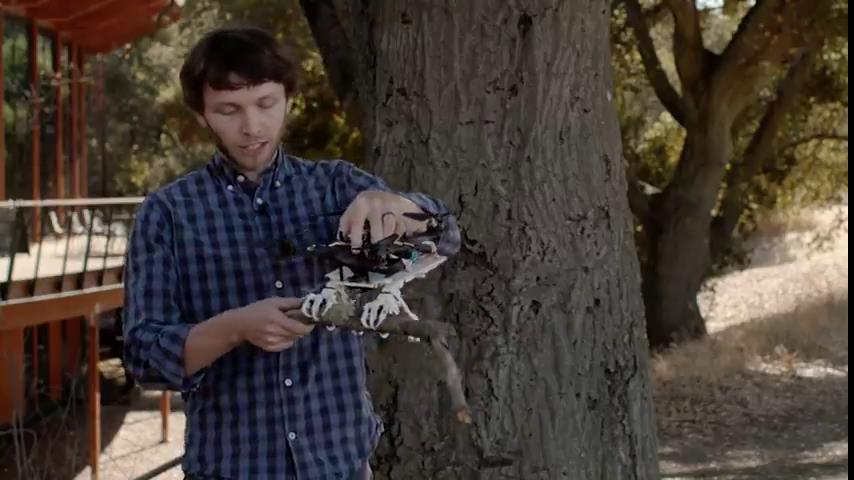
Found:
[623,0,832,347]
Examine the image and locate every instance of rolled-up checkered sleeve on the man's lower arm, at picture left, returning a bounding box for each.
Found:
[124,197,205,392]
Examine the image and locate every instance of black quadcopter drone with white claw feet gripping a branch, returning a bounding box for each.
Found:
[302,213,447,340]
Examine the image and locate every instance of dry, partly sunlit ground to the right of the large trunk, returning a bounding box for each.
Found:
[653,205,848,480]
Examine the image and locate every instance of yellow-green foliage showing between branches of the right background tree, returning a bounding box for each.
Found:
[612,1,848,251]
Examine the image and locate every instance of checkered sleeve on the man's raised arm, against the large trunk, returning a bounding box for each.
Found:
[336,161,460,257]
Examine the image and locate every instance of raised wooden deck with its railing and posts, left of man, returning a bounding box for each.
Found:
[0,197,169,479]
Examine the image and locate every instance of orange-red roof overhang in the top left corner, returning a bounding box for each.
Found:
[0,0,183,53]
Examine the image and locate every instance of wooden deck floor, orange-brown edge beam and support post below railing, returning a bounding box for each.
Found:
[0,236,139,478]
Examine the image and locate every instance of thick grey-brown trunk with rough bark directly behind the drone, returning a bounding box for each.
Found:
[336,0,658,480]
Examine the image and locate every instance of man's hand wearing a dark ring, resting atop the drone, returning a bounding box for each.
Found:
[338,190,427,251]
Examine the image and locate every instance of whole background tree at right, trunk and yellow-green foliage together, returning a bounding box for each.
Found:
[613,0,848,346]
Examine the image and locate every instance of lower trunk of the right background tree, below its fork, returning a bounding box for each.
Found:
[643,109,732,349]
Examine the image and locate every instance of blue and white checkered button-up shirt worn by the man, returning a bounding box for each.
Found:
[124,149,460,480]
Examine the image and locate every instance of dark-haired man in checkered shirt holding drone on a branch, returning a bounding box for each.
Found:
[125,28,459,480]
